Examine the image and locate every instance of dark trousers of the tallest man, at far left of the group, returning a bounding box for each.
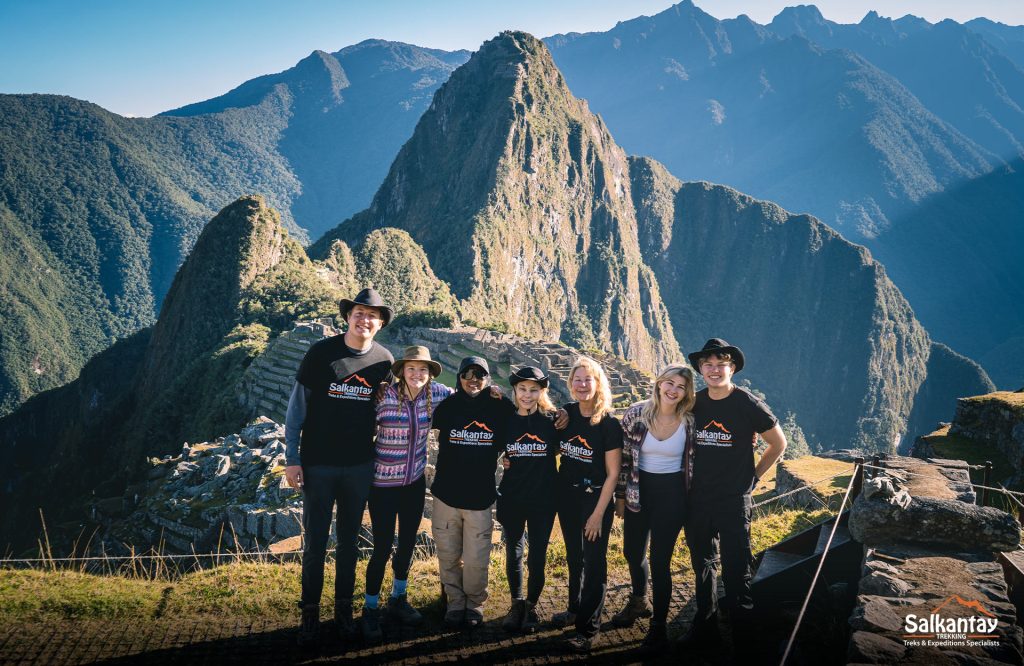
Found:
[302,460,374,606]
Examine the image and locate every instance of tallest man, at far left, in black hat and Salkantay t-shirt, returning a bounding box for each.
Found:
[285,289,394,644]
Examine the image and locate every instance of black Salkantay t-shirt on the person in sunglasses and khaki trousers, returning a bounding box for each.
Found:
[430,388,515,511]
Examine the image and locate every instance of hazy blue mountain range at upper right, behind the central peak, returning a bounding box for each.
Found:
[546,0,1024,384]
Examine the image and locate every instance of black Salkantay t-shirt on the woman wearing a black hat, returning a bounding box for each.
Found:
[498,411,559,506]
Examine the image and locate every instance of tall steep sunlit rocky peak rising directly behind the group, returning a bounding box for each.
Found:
[310,31,679,368]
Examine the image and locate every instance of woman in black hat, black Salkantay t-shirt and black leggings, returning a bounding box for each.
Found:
[497,366,559,632]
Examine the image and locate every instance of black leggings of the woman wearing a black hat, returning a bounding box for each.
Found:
[498,497,555,603]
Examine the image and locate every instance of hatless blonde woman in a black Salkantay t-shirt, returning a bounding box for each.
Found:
[552,357,623,653]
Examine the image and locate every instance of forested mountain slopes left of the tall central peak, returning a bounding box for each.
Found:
[0,40,468,415]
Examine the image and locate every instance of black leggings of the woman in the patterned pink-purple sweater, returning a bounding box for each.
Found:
[367,476,427,594]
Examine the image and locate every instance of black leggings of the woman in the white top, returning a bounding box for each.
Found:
[623,471,686,622]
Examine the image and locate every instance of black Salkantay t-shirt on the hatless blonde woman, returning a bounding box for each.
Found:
[558,403,623,487]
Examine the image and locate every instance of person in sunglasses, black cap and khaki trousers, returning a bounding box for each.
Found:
[430,357,515,628]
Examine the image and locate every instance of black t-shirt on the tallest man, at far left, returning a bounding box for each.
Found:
[296,335,394,467]
